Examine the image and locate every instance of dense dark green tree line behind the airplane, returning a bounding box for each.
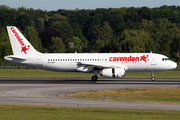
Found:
[0,5,180,61]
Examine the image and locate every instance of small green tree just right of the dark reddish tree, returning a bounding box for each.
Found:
[49,37,66,53]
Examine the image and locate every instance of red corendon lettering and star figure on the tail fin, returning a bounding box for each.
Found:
[10,27,30,54]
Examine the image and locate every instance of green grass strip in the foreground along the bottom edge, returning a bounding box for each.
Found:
[0,104,180,120]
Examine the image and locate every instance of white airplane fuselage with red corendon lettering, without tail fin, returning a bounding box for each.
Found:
[5,53,177,72]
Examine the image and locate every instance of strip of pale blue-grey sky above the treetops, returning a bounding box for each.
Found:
[0,0,180,11]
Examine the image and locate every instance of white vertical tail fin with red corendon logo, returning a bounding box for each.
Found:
[7,26,39,55]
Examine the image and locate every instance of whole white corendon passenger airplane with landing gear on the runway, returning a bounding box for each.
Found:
[4,26,177,81]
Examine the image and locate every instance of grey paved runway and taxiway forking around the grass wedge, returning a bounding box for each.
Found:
[0,78,180,110]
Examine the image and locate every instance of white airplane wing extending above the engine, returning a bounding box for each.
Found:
[77,62,128,72]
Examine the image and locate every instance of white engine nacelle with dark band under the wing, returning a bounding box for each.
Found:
[101,68,125,77]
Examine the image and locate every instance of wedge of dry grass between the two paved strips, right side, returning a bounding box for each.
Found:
[66,87,180,104]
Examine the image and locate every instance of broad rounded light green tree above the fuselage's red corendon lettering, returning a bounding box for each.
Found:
[120,30,154,52]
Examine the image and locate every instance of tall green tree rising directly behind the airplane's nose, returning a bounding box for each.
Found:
[141,18,179,57]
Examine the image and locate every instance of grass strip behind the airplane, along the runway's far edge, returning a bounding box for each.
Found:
[0,69,180,78]
